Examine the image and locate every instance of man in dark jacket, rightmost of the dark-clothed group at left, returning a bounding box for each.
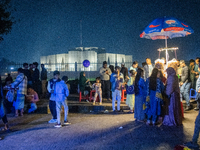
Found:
[41,64,47,97]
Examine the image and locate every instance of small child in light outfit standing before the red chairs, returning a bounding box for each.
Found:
[92,77,102,105]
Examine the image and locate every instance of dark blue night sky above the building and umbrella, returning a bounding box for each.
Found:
[0,0,200,62]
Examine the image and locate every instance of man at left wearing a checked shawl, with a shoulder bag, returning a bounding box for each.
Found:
[11,68,27,116]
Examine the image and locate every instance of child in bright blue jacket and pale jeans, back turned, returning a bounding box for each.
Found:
[54,76,70,128]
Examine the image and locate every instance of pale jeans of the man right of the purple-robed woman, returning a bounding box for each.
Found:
[180,82,191,106]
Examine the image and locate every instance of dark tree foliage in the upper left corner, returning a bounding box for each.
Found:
[0,0,14,41]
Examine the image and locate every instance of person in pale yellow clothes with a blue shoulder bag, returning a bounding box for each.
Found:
[126,70,136,114]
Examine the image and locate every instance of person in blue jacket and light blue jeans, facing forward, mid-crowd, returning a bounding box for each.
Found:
[110,66,124,113]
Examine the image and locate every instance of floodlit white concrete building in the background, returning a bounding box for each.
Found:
[40,47,132,71]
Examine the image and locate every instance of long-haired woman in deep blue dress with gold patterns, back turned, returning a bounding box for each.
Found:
[145,68,164,125]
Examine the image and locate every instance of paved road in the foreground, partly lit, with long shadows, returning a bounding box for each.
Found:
[0,110,198,150]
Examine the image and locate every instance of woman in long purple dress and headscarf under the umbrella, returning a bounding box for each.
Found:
[163,67,182,126]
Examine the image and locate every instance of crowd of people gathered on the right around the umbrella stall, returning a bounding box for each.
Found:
[79,57,200,147]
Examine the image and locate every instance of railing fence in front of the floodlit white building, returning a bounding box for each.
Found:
[0,62,132,80]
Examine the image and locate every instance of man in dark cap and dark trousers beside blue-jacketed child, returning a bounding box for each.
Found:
[47,71,61,123]
